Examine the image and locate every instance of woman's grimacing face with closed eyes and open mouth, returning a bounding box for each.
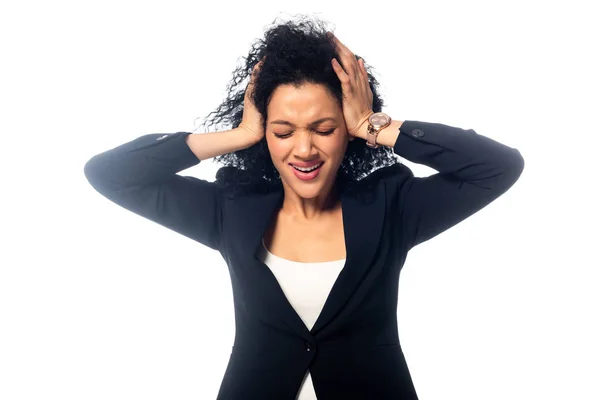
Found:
[265,83,349,199]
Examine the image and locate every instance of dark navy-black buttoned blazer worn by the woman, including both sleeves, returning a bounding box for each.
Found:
[84,121,524,400]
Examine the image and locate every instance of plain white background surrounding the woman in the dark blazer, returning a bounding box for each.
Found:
[0,0,600,400]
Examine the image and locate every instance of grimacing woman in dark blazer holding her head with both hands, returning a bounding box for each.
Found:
[85,15,524,400]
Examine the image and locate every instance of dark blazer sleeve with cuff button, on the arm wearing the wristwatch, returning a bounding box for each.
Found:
[393,121,525,249]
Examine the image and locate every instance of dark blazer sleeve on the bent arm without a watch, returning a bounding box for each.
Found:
[84,132,222,250]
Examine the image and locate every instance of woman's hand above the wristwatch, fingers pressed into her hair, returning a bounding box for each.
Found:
[330,33,373,140]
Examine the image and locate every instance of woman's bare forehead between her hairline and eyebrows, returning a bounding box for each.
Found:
[267,83,339,119]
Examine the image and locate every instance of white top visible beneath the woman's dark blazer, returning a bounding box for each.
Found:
[260,240,346,400]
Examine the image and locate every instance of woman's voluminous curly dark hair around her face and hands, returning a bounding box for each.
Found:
[197,16,399,196]
